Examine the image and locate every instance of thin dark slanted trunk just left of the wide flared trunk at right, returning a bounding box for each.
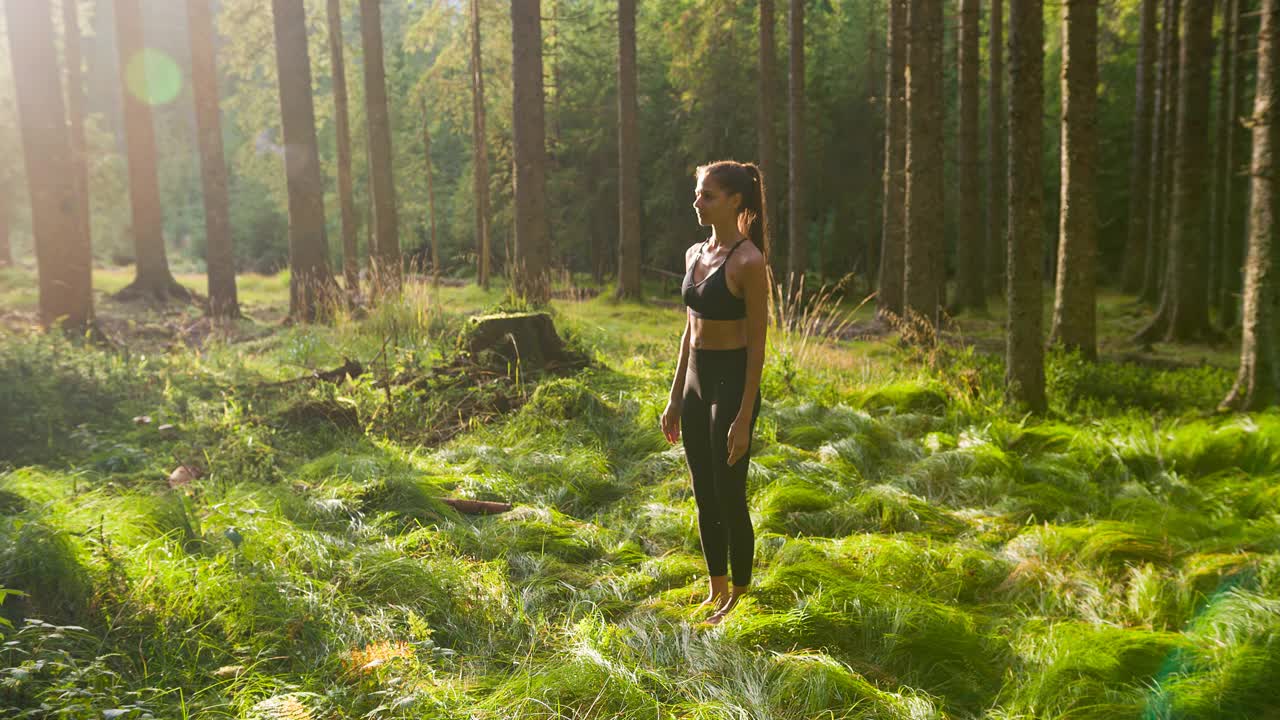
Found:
[1138,0,1181,302]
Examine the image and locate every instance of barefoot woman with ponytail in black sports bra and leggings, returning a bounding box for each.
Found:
[662,160,769,624]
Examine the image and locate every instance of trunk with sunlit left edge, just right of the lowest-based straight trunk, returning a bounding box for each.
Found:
[1050,0,1098,360]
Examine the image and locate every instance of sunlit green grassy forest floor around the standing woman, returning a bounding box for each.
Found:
[0,266,1280,720]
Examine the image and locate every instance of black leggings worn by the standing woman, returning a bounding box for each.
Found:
[680,347,760,585]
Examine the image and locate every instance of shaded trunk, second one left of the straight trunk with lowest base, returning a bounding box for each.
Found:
[954,0,987,310]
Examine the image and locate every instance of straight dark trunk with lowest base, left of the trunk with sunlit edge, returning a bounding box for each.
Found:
[1005,0,1047,413]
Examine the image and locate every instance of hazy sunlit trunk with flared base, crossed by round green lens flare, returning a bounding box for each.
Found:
[115,0,191,301]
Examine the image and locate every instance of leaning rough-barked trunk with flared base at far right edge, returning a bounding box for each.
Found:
[1220,0,1280,410]
